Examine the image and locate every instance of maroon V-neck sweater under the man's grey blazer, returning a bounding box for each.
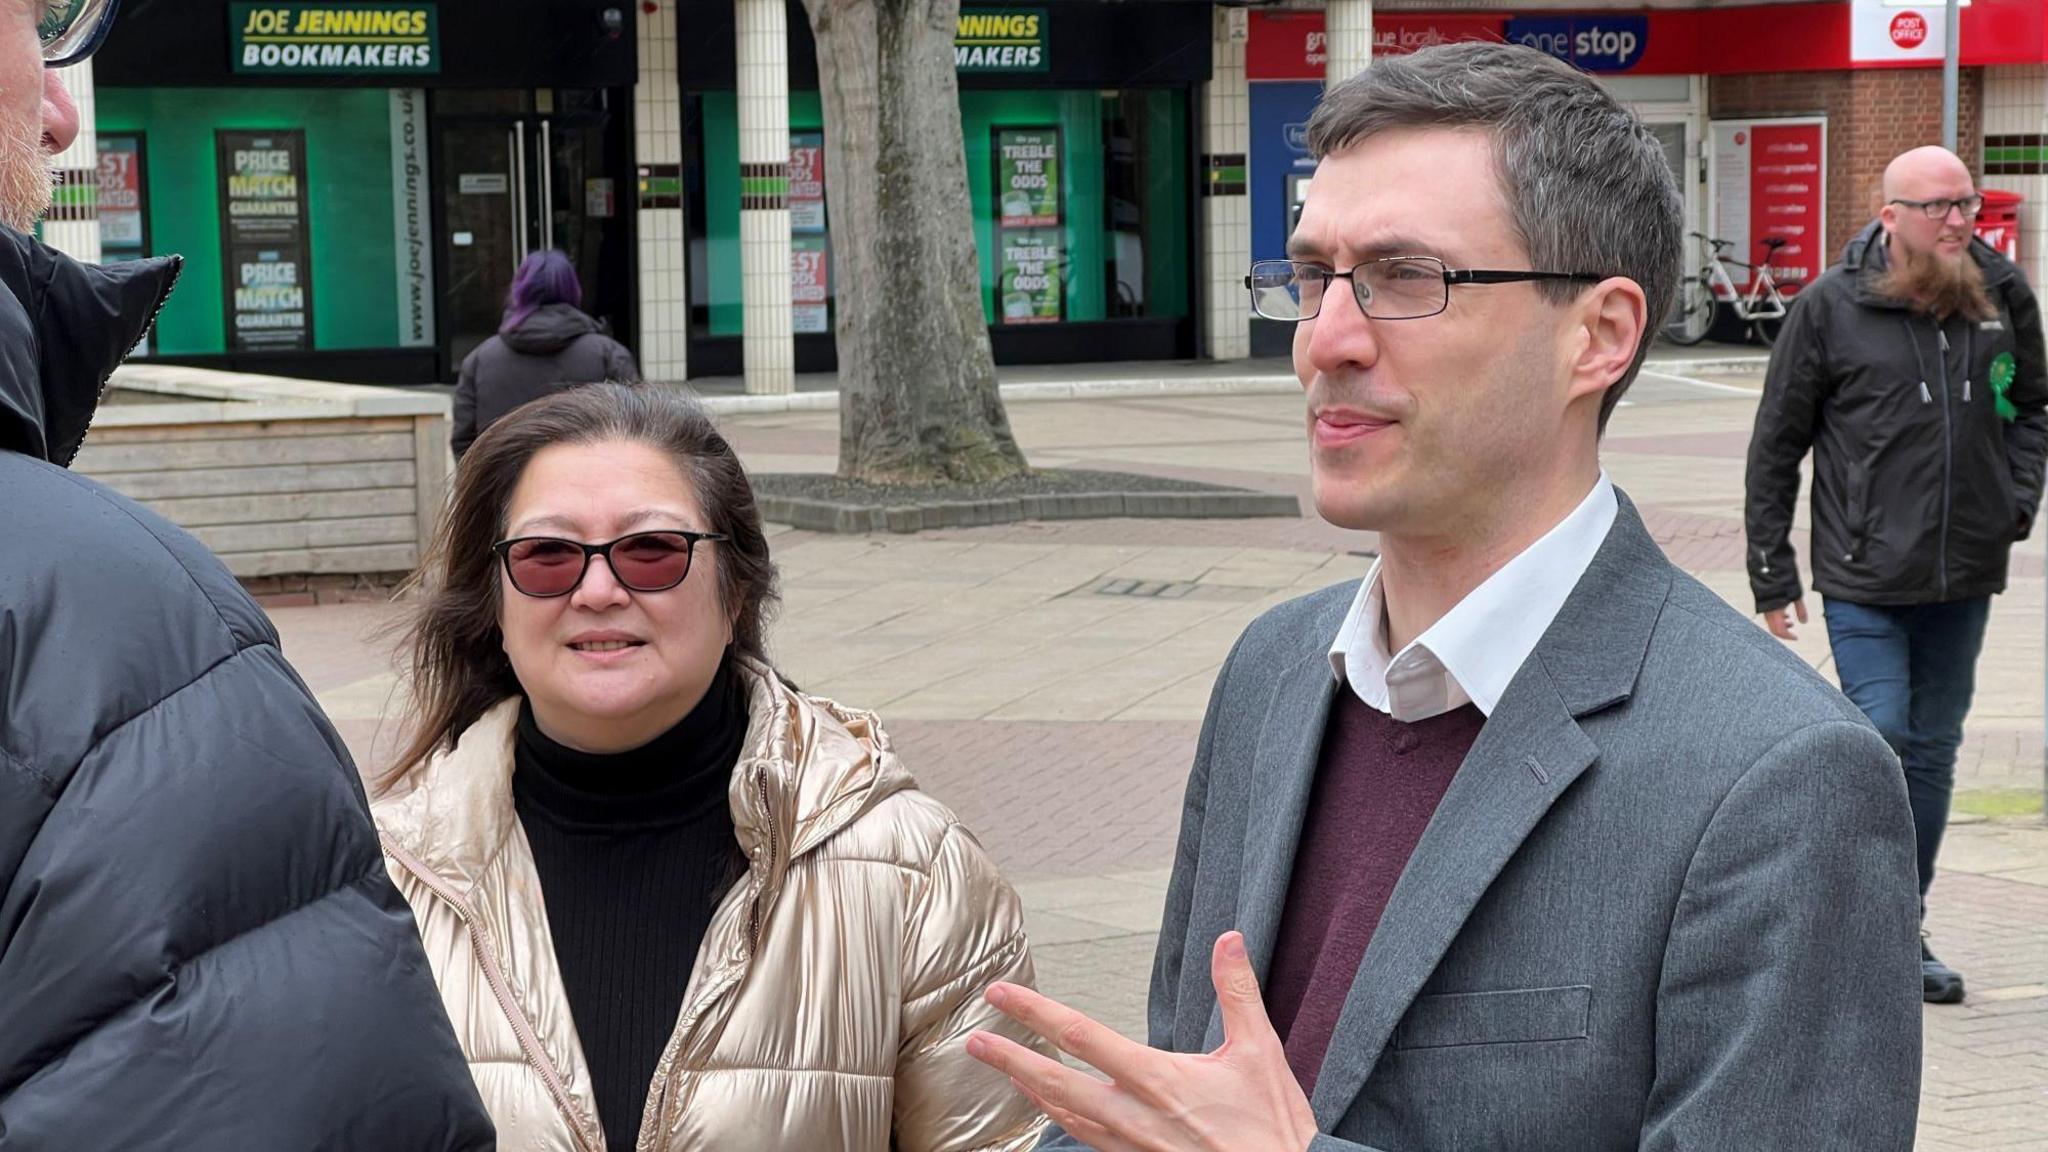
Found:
[1266,685,1487,1095]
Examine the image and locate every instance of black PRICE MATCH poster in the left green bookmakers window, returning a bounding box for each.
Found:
[213,129,313,353]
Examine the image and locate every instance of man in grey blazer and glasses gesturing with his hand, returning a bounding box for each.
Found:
[969,45,1921,1152]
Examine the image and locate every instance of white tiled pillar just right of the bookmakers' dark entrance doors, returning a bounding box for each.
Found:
[633,0,690,379]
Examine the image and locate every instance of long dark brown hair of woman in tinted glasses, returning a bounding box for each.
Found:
[373,383,778,793]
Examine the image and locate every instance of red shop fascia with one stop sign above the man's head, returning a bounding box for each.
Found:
[1245,0,2048,80]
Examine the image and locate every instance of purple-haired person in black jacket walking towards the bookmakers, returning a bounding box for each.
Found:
[449,250,639,457]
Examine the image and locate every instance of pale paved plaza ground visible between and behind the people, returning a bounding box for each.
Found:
[272,369,2048,1152]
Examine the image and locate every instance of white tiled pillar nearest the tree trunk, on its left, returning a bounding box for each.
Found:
[733,0,797,394]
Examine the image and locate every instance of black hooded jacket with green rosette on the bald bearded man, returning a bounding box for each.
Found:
[1745,223,2048,611]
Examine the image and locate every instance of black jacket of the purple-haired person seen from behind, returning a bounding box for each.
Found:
[449,303,639,455]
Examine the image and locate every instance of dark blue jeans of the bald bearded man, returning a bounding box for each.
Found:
[1823,596,1991,902]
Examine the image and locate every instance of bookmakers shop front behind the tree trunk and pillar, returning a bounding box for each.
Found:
[678,2,1210,375]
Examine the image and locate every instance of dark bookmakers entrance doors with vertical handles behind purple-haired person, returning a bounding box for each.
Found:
[434,90,633,381]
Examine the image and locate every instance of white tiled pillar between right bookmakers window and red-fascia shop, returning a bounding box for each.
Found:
[1202,4,1251,361]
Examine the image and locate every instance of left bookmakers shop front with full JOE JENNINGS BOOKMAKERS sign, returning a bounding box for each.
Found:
[94,0,635,383]
